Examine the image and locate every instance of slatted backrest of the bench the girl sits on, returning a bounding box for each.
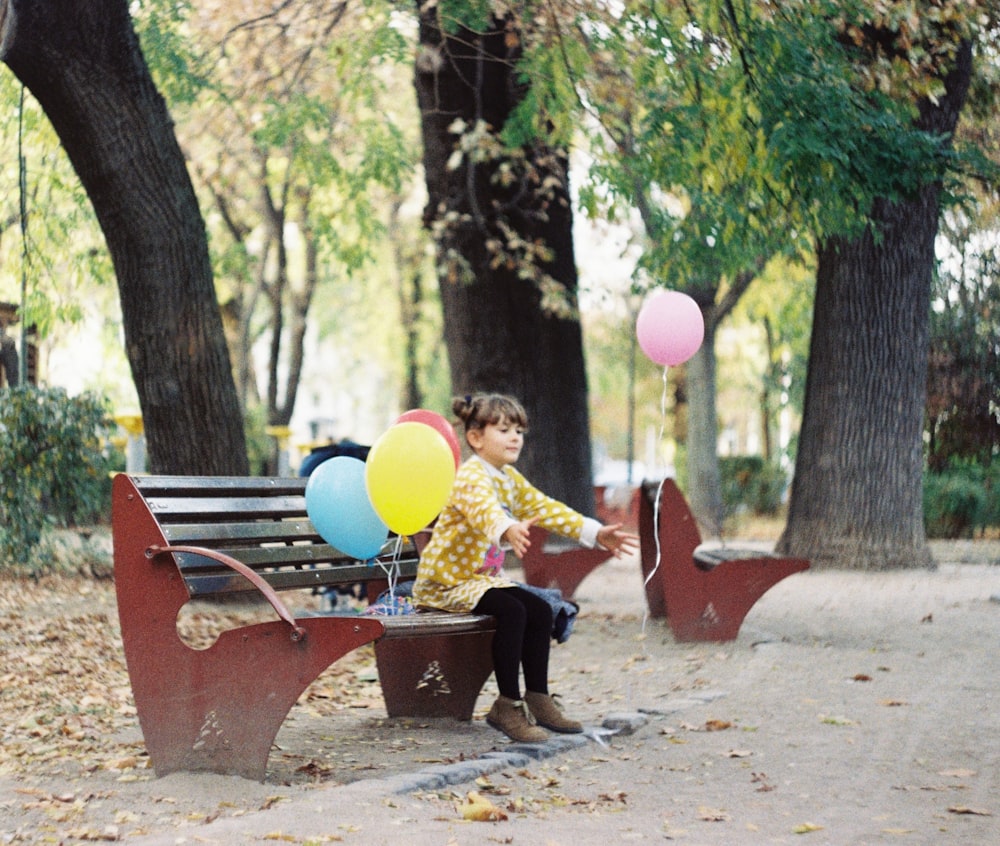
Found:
[121,476,418,597]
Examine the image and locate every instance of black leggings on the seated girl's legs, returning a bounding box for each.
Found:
[473,587,552,699]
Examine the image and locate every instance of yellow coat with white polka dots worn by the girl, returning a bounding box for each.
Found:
[413,456,601,611]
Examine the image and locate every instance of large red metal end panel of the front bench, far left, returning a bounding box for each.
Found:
[114,476,385,780]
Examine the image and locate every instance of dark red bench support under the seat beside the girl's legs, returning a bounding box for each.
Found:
[375,631,493,720]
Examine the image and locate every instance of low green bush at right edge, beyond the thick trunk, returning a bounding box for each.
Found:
[924,461,1000,538]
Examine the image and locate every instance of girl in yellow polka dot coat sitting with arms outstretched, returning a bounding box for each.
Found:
[413,394,639,743]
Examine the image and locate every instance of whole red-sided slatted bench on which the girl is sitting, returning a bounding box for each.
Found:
[112,474,493,780]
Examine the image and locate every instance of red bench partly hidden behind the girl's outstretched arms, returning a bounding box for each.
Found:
[521,486,639,599]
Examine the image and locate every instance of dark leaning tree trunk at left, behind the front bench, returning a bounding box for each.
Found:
[0,0,248,475]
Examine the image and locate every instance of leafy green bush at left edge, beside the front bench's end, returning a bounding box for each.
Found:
[0,386,113,568]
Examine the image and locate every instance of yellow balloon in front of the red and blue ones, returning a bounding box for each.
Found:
[365,421,455,535]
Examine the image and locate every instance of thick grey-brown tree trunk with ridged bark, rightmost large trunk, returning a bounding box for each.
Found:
[778,39,971,570]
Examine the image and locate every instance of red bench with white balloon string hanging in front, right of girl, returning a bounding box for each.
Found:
[639,479,809,642]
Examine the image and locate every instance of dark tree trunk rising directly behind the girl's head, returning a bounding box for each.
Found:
[415,4,594,514]
